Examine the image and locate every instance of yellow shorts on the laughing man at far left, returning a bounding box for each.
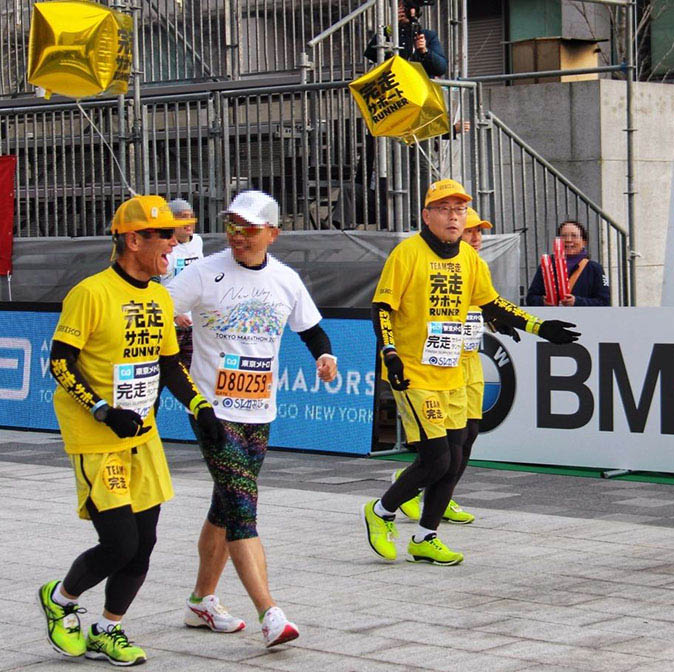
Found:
[70,436,173,520]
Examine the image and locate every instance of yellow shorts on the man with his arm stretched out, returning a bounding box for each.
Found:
[393,387,466,443]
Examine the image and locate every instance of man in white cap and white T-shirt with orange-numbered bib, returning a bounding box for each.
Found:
[168,191,337,646]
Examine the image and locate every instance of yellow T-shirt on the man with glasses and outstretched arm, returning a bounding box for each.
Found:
[372,234,498,390]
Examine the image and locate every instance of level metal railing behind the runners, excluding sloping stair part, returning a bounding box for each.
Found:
[0,82,477,237]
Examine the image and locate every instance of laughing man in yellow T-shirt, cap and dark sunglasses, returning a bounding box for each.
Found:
[38,196,222,666]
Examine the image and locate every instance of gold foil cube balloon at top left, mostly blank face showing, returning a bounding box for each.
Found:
[28,0,133,98]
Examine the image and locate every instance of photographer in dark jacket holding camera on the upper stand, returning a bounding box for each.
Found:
[365,0,447,77]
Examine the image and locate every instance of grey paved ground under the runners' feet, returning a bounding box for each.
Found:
[0,430,674,672]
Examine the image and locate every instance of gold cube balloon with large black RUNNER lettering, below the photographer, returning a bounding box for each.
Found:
[349,56,449,144]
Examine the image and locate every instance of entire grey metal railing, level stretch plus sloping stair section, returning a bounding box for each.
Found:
[0,81,629,305]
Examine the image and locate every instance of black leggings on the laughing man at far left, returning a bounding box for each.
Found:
[63,500,160,616]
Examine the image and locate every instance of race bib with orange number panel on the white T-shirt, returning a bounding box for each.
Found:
[215,355,273,399]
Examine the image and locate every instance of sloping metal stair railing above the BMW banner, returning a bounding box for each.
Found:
[477,112,630,306]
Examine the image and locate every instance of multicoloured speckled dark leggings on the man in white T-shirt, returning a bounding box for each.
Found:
[189,415,269,541]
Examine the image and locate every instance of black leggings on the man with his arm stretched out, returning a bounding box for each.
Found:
[381,428,467,530]
